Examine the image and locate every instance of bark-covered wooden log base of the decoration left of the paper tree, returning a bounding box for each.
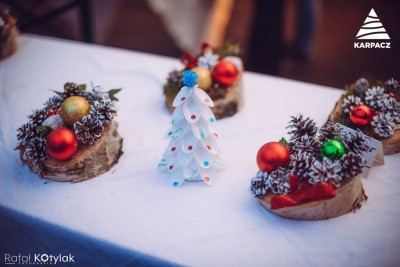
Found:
[24,121,123,182]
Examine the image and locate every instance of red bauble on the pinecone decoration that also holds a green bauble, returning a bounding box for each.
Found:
[257,142,290,172]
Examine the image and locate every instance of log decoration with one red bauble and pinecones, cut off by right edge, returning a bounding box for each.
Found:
[328,78,400,155]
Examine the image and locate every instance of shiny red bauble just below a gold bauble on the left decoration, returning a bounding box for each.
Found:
[46,128,78,160]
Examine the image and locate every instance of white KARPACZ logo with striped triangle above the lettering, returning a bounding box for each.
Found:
[354,8,390,48]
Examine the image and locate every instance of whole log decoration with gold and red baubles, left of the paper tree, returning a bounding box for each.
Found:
[17,83,122,182]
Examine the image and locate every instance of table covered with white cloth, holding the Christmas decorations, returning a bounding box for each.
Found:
[0,35,400,267]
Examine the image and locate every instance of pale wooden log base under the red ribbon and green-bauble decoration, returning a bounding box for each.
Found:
[258,175,366,220]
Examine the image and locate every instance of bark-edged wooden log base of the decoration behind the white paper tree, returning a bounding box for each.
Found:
[165,71,244,119]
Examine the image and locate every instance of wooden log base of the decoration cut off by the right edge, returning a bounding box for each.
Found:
[328,96,400,155]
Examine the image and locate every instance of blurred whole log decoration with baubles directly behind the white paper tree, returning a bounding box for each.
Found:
[164,43,243,119]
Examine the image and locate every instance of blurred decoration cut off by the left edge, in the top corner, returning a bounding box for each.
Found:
[0,3,18,59]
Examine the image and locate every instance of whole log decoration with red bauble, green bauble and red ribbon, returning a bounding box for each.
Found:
[250,114,370,220]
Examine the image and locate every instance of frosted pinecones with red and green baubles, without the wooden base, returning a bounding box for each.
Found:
[250,114,369,200]
